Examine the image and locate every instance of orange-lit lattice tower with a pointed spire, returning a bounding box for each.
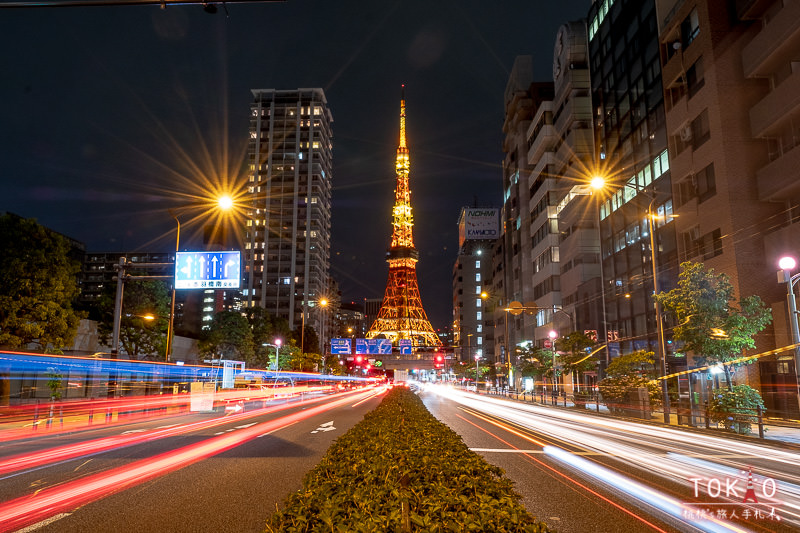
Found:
[367,87,442,346]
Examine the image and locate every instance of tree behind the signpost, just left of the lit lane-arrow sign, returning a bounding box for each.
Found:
[97,279,170,358]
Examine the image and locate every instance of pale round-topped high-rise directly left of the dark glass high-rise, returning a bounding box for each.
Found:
[552,20,602,344]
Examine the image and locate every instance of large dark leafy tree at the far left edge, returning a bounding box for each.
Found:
[0,214,80,352]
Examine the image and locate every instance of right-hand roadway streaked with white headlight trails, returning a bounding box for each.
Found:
[420,386,800,533]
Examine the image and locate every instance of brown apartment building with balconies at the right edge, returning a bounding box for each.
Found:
[657,0,800,417]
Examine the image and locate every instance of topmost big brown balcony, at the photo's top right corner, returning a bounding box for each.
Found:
[742,2,800,78]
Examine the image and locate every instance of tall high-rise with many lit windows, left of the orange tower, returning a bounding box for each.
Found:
[243,89,333,331]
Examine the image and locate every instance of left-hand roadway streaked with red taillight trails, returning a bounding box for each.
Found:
[0,390,382,533]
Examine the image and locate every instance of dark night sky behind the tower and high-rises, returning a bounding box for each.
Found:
[0,0,591,328]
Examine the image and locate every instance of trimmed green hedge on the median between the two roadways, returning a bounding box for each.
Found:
[266,387,550,532]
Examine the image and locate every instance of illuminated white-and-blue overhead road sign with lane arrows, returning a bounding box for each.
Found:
[175,251,242,289]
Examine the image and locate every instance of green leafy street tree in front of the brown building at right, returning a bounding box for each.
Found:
[655,261,772,388]
